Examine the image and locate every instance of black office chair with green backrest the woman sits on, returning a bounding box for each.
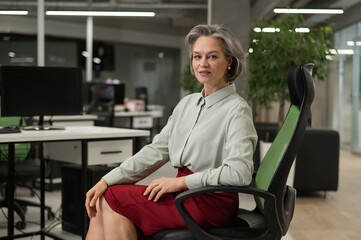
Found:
[152,63,315,240]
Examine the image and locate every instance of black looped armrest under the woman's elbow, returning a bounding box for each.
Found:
[175,186,282,240]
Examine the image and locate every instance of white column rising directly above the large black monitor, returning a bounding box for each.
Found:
[37,0,45,66]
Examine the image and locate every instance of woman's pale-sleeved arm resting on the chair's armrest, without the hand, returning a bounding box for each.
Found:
[185,105,257,189]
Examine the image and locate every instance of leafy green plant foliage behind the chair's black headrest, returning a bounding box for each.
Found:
[247,14,332,126]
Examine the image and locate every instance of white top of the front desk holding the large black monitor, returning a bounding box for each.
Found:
[0,126,150,143]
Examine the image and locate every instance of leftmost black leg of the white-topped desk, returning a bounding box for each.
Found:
[6,143,15,239]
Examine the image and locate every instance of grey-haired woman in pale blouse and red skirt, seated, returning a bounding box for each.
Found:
[86,25,257,240]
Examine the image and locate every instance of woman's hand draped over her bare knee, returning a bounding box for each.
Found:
[85,179,108,218]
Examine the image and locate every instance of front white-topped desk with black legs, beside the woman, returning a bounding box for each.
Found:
[0,126,149,240]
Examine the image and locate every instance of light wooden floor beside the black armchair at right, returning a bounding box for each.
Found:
[289,151,361,240]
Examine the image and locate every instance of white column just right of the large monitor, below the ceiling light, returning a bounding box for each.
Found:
[85,17,93,82]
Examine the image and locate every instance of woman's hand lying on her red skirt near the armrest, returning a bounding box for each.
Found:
[144,177,187,202]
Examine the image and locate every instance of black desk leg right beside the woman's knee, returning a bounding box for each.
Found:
[80,140,88,239]
